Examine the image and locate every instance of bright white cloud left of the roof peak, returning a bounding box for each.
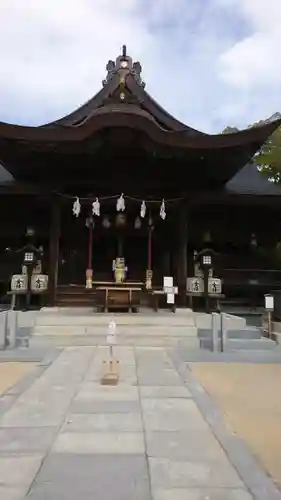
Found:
[0,0,153,117]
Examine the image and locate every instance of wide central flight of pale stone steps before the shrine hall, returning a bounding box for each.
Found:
[30,308,199,349]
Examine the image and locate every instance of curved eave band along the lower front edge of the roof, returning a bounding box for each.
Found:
[0,103,281,146]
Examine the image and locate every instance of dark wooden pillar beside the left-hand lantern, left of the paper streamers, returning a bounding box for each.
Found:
[49,196,61,307]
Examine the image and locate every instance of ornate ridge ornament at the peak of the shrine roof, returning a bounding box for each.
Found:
[102,45,145,88]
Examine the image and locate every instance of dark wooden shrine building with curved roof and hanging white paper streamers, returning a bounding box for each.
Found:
[0,46,281,312]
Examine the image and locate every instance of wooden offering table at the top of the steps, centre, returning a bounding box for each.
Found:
[95,282,142,312]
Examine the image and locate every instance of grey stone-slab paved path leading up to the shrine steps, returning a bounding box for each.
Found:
[0,347,281,500]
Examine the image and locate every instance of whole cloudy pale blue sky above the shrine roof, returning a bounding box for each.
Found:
[0,0,281,133]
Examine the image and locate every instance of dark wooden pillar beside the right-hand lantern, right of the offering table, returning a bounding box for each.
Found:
[177,203,188,307]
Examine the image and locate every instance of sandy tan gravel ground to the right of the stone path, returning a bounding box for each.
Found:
[189,363,281,487]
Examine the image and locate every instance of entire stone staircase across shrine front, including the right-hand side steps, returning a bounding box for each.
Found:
[9,307,281,354]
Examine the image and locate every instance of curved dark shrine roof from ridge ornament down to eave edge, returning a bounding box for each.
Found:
[0,46,281,145]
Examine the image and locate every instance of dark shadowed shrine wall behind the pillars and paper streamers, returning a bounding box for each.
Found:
[0,194,281,302]
